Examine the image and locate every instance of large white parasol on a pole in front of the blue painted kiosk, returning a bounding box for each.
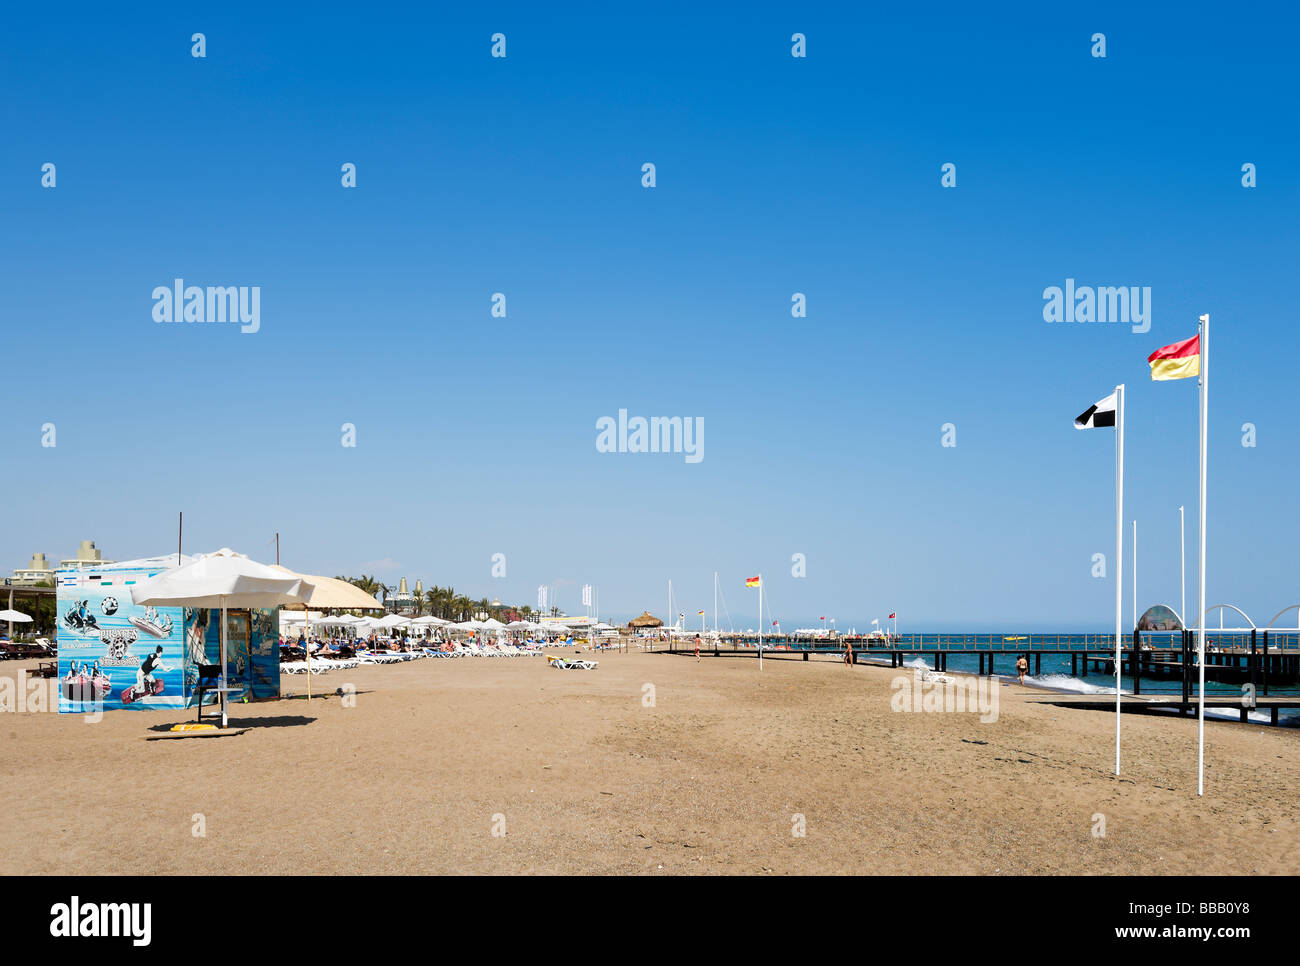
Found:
[131,547,312,728]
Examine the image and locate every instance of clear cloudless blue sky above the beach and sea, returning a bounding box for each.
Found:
[0,4,1300,631]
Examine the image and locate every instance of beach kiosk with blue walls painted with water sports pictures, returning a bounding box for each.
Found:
[55,554,280,714]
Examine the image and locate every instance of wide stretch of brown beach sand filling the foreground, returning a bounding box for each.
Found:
[0,649,1300,875]
